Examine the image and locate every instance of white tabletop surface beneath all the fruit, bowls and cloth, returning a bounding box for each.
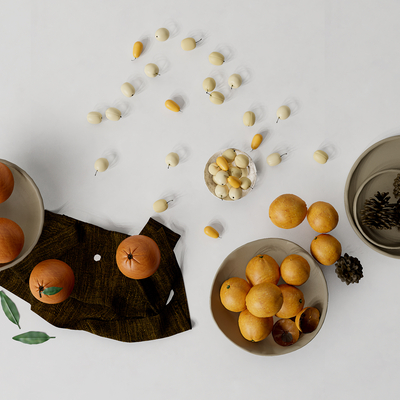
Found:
[0,0,400,400]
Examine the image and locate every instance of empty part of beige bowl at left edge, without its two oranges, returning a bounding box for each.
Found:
[0,160,44,271]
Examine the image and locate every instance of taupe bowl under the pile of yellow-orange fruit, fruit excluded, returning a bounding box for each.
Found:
[211,238,328,356]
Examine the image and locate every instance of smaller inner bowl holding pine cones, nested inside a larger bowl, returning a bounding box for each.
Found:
[353,169,400,249]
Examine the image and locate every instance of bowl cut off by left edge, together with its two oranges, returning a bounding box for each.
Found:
[0,160,44,271]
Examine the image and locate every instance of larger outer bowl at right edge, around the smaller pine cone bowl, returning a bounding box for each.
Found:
[344,135,400,258]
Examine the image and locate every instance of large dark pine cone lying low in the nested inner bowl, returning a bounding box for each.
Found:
[361,192,399,230]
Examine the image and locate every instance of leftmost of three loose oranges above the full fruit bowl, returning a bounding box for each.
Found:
[269,194,307,229]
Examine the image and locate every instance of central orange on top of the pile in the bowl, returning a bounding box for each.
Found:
[246,282,283,318]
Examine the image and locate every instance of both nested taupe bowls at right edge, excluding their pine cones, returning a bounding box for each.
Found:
[344,135,400,258]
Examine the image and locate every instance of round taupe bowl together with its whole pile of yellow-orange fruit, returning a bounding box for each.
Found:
[211,238,328,356]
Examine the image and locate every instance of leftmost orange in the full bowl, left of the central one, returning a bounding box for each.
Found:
[219,277,251,312]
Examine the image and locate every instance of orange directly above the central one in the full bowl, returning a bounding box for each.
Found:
[246,254,280,286]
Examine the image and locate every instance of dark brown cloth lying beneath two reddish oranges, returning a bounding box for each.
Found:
[0,211,191,342]
